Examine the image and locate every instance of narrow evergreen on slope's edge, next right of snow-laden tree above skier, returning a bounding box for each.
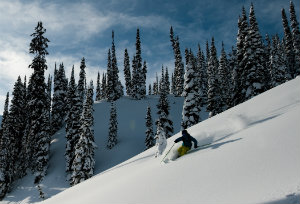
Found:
[207,38,222,117]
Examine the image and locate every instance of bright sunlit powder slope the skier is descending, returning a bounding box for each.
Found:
[37,77,300,204]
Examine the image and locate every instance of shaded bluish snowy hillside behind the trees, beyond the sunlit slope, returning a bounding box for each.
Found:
[0,96,207,203]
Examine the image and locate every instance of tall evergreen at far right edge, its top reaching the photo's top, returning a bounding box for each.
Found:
[290,1,300,76]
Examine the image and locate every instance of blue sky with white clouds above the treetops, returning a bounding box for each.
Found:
[0,0,300,113]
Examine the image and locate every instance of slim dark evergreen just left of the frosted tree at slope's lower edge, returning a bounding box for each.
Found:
[65,66,82,179]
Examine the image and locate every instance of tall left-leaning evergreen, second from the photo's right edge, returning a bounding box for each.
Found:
[281,9,296,80]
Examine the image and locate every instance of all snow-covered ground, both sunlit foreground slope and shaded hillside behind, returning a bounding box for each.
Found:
[3,78,300,204]
